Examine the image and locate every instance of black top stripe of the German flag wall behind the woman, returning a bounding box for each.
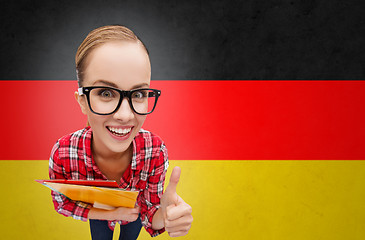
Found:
[0,0,365,80]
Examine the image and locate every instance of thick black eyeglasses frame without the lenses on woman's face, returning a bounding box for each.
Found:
[77,86,161,115]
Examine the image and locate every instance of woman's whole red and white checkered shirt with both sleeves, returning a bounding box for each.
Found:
[49,127,169,236]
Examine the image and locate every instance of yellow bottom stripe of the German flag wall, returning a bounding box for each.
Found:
[0,160,365,240]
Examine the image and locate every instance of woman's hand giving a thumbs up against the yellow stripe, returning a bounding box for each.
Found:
[161,167,193,237]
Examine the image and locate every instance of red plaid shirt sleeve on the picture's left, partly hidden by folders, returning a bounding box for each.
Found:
[49,142,91,221]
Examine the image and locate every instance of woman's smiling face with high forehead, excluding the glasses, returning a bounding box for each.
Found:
[76,41,151,156]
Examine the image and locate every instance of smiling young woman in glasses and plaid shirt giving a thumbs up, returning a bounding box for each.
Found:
[49,25,192,239]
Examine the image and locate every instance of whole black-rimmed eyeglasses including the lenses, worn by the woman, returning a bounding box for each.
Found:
[78,86,161,115]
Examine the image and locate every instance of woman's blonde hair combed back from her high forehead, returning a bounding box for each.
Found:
[75,25,149,87]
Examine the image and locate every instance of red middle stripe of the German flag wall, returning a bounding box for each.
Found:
[0,81,365,160]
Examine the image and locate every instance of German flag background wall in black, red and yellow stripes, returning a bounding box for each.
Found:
[0,0,365,240]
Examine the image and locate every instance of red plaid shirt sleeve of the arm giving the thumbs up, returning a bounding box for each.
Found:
[140,142,169,237]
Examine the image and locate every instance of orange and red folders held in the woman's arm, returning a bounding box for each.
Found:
[36,179,139,210]
